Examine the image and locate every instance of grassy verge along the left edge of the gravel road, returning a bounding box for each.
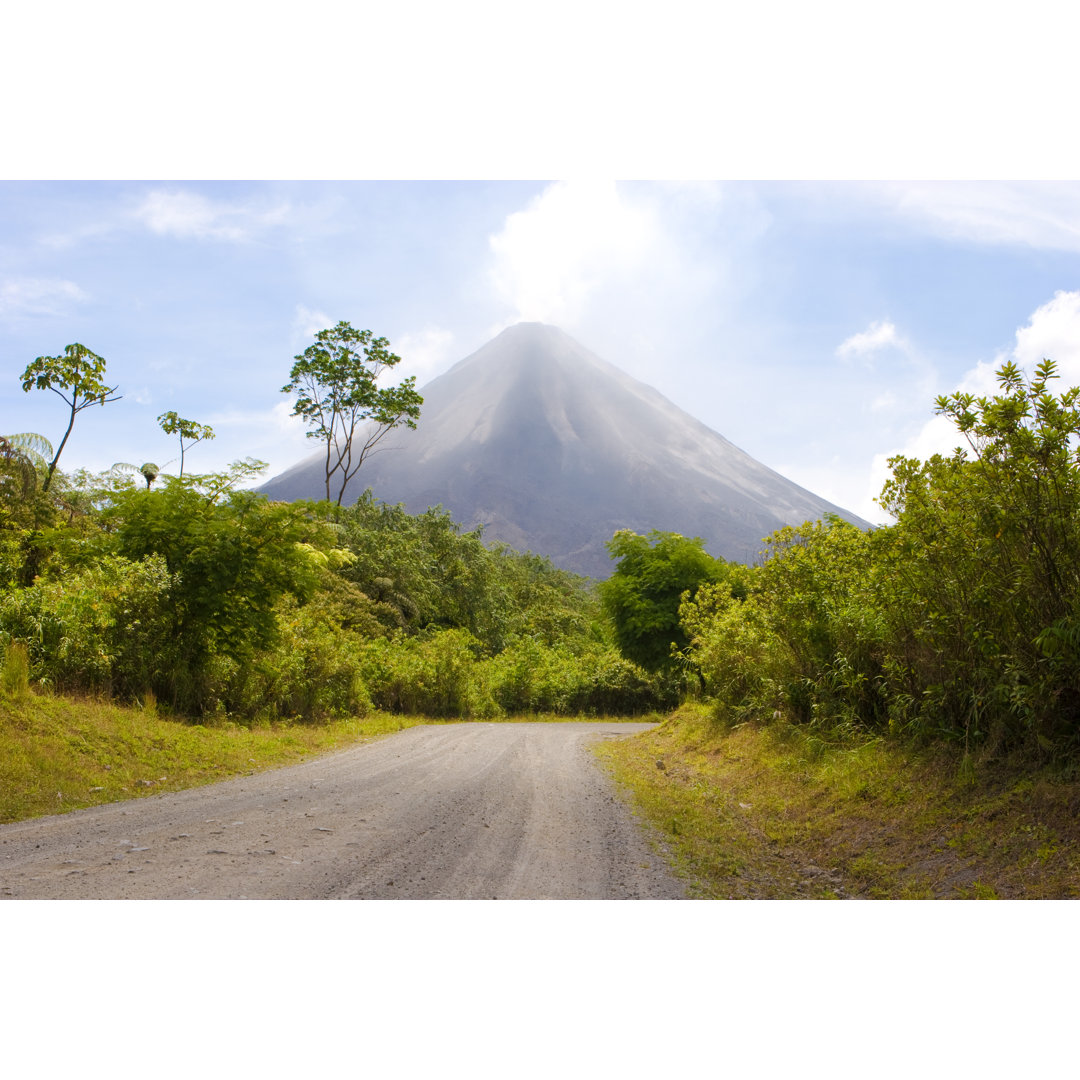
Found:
[0,692,432,822]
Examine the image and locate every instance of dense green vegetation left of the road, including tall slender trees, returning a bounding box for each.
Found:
[0,334,677,743]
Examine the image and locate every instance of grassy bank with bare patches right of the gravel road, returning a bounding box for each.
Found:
[596,705,1080,900]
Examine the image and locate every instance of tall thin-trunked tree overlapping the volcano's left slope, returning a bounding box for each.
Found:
[281,322,423,505]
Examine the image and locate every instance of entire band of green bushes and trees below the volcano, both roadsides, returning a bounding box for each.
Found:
[0,336,1080,759]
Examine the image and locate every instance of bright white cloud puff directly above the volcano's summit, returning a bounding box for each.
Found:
[489,180,660,323]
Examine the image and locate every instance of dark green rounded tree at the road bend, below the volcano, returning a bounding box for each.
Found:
[599,529,728,672]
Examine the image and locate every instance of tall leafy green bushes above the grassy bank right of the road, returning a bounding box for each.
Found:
[683,361,1080,754]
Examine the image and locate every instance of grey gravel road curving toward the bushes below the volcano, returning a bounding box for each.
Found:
[0,723,684,900]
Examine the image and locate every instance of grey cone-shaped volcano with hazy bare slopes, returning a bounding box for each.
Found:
[260,323,869,578]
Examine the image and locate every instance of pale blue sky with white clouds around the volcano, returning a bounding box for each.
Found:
[0,179,1080,524]
